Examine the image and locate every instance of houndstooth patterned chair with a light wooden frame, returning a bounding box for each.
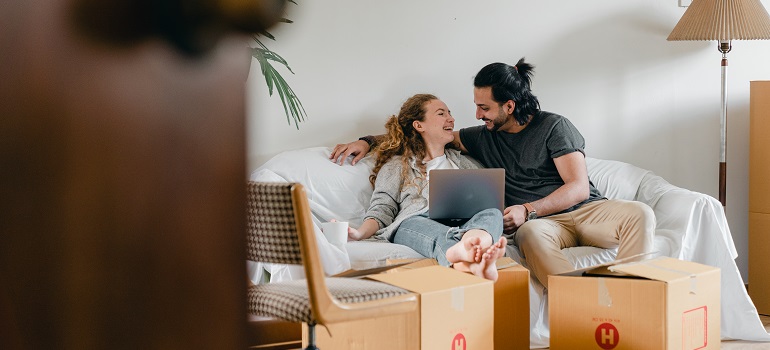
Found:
[247,182,417,349]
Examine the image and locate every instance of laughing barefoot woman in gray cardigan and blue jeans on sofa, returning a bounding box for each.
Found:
[348,94,506,281]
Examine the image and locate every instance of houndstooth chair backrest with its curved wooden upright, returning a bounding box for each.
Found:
[246,181,332,308]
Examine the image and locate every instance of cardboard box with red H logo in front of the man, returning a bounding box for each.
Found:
[548,257,721,350]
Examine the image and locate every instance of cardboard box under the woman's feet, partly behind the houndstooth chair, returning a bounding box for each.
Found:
[310,262,494,350]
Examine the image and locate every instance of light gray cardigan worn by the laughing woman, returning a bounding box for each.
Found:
[364,149,479,241]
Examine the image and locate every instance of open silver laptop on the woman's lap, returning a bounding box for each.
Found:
[428,168,505,221]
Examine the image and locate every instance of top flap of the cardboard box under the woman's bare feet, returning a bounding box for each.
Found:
[367,266,492,294]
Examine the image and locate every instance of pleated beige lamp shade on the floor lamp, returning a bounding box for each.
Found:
[666,0,770,42]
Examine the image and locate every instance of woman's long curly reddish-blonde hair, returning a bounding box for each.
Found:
[369,94,438,186]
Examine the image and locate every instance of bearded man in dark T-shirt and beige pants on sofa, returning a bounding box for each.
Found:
[330,58,655,288]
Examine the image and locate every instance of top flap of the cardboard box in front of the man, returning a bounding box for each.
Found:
[609,257,719,282]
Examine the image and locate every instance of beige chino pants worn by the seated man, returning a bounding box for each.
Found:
[514,199,655,288]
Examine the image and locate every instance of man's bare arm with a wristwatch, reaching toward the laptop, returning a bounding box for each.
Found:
[503,152,590,231]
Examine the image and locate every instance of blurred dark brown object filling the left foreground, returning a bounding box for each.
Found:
[0,0,283,349]
